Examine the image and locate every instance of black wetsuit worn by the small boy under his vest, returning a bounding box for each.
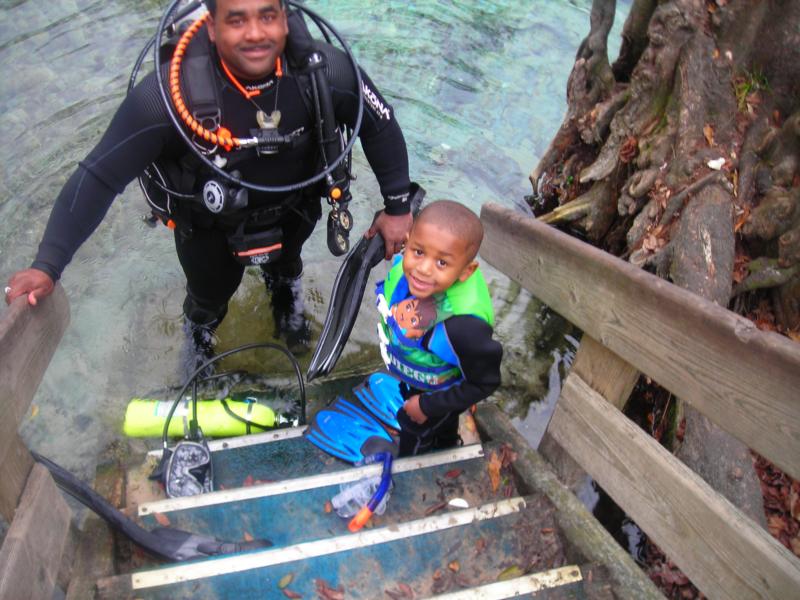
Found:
[397,315,503,456]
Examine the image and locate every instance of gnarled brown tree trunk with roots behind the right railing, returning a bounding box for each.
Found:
[530,0,800,584]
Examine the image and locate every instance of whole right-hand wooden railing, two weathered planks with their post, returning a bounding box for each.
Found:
[481,205,800,599]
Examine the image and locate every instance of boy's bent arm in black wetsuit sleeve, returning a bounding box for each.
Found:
[420,315,503,417]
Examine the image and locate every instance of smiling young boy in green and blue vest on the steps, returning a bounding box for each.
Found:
[376,200,503,456]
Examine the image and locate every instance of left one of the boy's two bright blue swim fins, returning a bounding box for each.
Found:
[304,397,397,464]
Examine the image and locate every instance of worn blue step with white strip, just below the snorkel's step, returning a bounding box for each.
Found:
[98,497,567,600]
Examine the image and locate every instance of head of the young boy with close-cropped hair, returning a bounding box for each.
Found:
[403,200,483,298]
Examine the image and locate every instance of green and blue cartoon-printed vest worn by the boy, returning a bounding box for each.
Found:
[375,255,494,391]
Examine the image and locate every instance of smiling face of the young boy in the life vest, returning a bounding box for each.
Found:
[403,221,478,299]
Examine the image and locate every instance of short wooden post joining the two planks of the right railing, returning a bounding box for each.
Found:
[539,334,639,494]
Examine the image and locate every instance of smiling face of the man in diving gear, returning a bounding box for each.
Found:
[208,0,289,79]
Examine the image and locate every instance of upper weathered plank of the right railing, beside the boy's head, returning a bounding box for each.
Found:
[481,204,800,478]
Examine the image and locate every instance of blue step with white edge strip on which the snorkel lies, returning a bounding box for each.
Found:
[139,444,500,547]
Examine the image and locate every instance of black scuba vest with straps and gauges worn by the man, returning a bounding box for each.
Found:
[139,10,352,255]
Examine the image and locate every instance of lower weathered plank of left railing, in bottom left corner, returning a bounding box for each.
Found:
[0,464,70,600]
